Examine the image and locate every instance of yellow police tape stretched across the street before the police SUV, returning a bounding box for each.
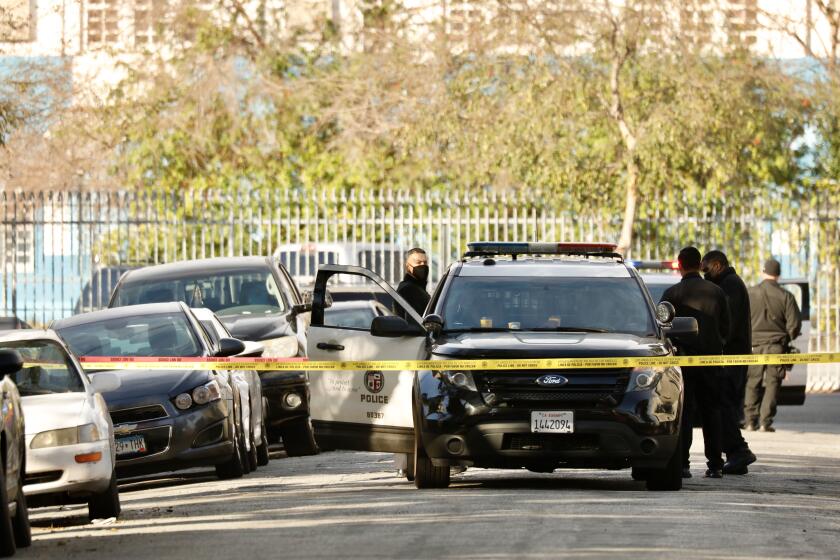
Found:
[82,352,840,371]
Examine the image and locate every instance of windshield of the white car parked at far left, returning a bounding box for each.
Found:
[0,340,85,397]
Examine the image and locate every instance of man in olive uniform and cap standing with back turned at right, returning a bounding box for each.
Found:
[744,259,802,432]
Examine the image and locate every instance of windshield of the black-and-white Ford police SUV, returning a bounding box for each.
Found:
[443,276,654,336]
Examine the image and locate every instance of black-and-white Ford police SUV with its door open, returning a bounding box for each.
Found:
[308,243,697,490]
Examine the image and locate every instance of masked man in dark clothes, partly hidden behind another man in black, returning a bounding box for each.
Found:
[701,251,756,474]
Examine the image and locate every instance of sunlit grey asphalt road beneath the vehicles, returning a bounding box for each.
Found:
[18,395,840,560]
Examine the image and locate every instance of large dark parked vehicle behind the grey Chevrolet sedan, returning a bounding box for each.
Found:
[109,257,318,456]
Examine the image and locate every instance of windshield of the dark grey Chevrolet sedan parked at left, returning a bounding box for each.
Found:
[58,313,201,357]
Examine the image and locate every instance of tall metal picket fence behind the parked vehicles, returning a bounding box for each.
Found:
[0,190,840,351]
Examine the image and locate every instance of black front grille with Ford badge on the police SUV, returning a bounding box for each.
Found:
[476,369,631,406]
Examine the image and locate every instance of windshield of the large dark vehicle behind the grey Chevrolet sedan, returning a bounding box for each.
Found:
[112,267,286,317]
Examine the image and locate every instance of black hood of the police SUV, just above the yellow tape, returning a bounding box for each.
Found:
[432,331,669,359]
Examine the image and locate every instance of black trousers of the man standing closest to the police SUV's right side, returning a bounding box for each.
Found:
[682,367,723,469]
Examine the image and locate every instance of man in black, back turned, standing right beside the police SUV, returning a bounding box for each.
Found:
[662,247,729,478]
